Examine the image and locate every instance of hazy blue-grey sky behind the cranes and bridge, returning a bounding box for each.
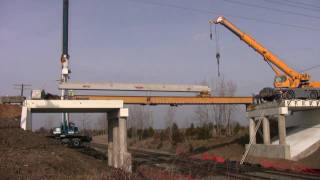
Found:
[0,0,320,129]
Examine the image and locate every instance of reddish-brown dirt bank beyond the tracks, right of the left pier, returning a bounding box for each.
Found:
[127,132,320,170]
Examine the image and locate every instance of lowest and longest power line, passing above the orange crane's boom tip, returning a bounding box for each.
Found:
[127,0,320,31]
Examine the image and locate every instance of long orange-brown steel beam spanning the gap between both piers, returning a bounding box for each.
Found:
[70,95,253,105]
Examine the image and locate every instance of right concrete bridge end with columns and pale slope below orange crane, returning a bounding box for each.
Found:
[247,99,320,160]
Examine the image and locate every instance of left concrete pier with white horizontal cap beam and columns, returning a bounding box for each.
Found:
[20,100,132,172]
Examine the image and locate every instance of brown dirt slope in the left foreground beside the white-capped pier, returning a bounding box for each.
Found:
[0,105,137,179]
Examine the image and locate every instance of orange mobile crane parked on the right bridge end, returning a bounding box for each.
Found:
[209,16,320,101]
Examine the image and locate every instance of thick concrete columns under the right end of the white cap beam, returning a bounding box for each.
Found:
[108,108,132,172]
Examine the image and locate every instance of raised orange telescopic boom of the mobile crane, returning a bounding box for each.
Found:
[209,16,310,88]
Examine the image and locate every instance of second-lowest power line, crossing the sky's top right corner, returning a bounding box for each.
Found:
[224,0,320,19]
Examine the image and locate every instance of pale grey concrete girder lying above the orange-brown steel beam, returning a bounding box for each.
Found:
[59,83,211,93]
